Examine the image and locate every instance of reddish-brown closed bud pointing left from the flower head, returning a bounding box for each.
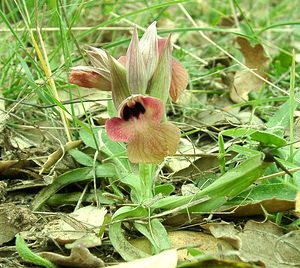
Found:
[68,66,111,91]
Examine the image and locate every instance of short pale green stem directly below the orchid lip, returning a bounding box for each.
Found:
[139,164,155,201]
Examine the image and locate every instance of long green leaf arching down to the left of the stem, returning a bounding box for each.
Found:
[32,164,116,210]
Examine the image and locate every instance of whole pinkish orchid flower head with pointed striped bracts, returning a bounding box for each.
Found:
[69,22,188,163]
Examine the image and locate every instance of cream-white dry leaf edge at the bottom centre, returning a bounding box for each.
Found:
[110,249,177,268]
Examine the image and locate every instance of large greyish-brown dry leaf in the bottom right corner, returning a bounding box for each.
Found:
[205,220,300,268]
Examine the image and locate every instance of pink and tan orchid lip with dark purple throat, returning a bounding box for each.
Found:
[106,95,180,163]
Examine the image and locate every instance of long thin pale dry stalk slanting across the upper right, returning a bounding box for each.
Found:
[178,3,300,103]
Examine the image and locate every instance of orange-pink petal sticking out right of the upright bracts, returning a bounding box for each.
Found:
[170,59,189,102]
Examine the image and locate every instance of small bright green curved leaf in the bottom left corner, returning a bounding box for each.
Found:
[16,234,57,268]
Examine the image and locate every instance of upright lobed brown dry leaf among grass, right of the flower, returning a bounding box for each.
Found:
[230,37,268,103]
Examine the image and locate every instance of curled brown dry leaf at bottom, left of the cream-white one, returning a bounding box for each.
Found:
[39,248,104,268]
